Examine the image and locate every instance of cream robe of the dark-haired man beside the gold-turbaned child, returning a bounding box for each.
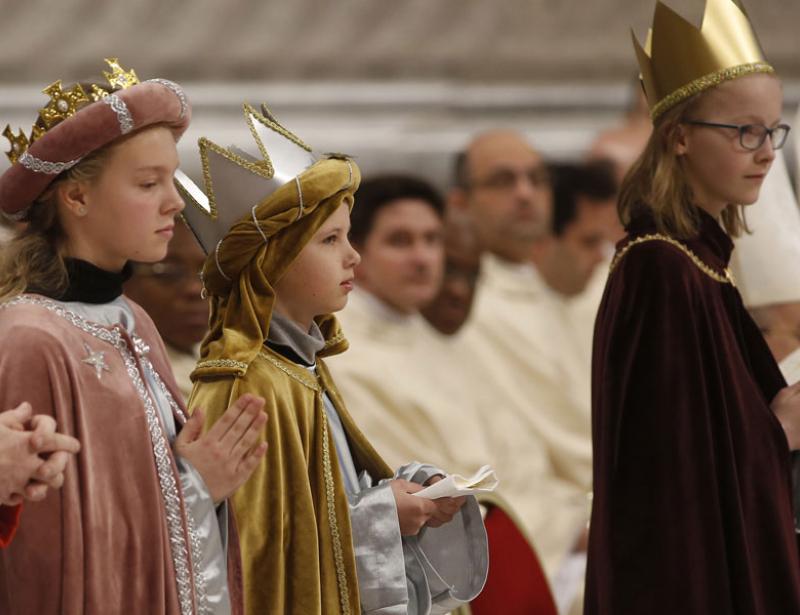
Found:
[327,289,490,474]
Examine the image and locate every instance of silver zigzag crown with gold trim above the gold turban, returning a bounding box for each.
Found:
[175,104,319,254]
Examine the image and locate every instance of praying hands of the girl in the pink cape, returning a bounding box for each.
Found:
[175,395,267,504]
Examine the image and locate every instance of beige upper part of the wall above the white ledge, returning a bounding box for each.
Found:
[0,0,800,83]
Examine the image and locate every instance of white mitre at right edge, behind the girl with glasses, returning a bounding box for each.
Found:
[731,150,800,308]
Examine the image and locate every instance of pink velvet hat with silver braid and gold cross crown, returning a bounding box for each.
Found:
[0,58,191,220]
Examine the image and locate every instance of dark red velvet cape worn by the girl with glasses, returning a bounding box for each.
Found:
[585,214,800,615]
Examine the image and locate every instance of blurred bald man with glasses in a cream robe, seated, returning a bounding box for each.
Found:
[450,130,592,612]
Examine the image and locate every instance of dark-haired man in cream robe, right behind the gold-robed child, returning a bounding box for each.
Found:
[329,176,490,474]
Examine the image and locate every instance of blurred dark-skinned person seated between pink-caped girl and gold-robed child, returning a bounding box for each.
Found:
[124,220,208,400]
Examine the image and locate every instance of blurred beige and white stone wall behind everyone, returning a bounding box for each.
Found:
[0,0,800,187]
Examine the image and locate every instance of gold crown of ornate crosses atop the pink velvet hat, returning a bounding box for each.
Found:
[3,58,139,164]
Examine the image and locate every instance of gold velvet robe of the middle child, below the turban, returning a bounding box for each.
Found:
[189,317,393,615]
